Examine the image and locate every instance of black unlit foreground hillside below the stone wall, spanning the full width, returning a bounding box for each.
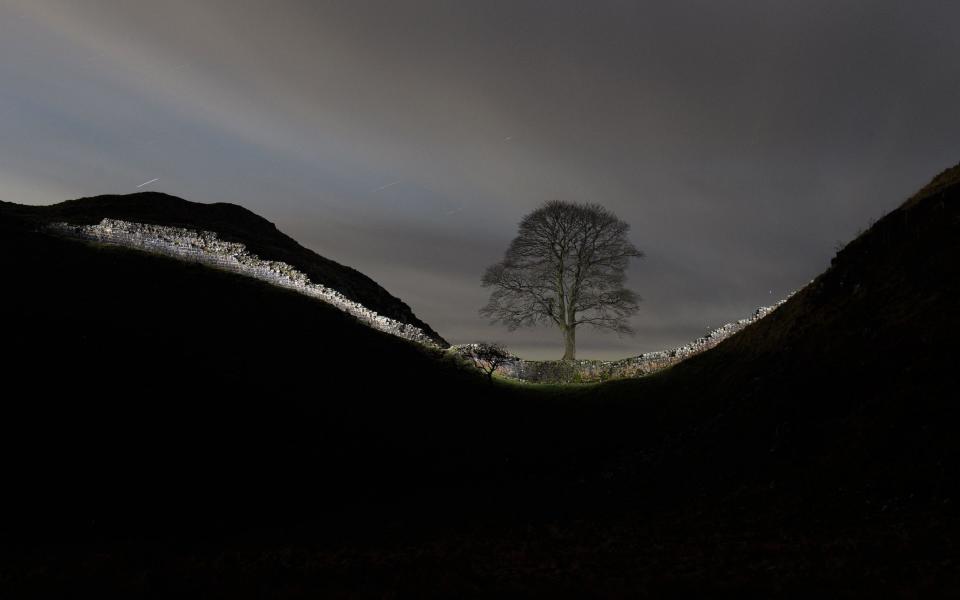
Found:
[0,165,960,597]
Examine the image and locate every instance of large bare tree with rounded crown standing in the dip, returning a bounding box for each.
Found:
[480,200,643,360]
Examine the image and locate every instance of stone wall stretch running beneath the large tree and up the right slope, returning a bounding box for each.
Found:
[451,292,795,383]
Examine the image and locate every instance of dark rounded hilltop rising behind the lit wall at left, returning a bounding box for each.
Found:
[0,192,447,346]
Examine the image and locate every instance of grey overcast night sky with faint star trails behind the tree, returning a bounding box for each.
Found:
[0,0,960,358]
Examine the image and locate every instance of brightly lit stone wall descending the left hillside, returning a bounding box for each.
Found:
[47,219,439,348]
